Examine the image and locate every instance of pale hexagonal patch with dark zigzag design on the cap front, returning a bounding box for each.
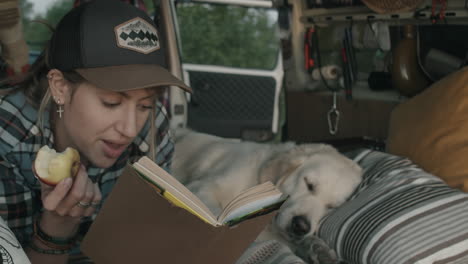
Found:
[114,17,159,54]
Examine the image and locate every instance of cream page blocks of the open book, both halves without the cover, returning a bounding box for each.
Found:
[132,157,286,226]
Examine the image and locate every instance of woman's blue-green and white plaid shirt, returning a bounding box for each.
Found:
[0,92,174,254]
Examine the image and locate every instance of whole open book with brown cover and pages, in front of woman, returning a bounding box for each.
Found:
[80,158,285,264]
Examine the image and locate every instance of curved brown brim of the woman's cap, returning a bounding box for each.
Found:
[76,64,192,93]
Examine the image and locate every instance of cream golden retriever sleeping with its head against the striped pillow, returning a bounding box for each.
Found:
[172,129,362,260]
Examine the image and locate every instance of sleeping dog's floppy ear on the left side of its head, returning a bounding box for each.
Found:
[259,151,304,183]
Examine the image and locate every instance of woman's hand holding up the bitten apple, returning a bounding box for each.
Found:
[41,165,102,235]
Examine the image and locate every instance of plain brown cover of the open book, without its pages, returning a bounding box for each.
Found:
[81,165,275,264]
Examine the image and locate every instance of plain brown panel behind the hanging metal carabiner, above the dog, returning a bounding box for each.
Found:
[287,92,397,142]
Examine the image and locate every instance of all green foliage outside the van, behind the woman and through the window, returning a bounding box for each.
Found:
[20,0,279,69]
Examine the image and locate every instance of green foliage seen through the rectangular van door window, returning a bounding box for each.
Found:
[177,4,279,69]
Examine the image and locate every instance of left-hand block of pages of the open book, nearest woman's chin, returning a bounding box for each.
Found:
[133,157,219,226]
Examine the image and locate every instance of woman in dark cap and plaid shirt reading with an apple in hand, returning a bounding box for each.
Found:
[0,1,191,264]
